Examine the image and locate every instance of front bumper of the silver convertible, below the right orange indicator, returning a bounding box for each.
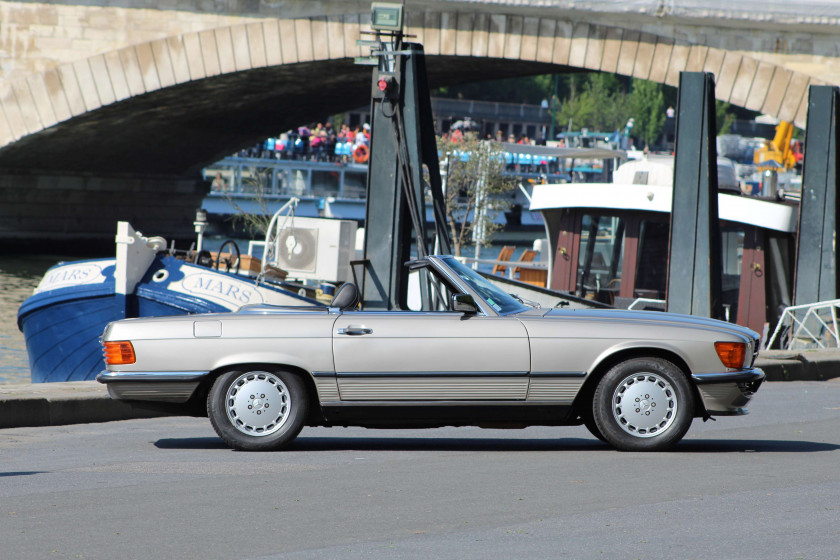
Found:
[691,368,764,416]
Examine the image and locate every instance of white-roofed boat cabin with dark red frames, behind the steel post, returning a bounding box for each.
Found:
[531,157,799,333]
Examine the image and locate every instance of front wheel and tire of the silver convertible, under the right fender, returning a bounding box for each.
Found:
[592,358,694,451]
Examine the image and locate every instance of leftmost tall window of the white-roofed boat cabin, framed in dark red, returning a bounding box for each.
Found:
[576,214,625,304]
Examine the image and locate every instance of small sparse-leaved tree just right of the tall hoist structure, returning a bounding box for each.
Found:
[438,134,514,255]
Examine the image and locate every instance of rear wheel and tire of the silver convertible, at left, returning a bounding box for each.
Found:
[207,370,309,451]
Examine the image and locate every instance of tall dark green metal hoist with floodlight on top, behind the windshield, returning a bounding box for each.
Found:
[355,2,451,309]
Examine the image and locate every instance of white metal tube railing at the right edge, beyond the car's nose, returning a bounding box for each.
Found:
[764,299,840,350]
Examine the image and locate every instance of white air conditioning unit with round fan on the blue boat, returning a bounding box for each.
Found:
[275,217,357,282]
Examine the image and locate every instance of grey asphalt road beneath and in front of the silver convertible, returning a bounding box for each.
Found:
[0,381,840,560]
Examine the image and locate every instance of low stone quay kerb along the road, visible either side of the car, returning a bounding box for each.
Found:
[0,350,840,429]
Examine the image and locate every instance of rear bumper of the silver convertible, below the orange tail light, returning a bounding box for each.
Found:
[96,371,210,403]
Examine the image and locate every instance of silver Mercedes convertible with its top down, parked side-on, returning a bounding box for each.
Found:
[97,256,764,451]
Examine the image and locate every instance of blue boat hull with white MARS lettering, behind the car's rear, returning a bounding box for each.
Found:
[18,256,317,383]
